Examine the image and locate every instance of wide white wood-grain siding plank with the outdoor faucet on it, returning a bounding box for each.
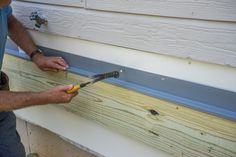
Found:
[12,2,236,66]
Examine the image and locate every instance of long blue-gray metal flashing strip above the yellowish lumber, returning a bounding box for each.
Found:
[6,40,236,120]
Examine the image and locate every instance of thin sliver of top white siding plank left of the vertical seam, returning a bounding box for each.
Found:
[16,0,85,7]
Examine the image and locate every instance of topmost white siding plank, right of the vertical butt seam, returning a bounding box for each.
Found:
[86,0,236,21]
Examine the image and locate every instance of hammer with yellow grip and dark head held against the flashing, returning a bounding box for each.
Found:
[67,71,120,94]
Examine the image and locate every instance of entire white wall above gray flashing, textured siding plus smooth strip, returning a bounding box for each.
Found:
[12,0,236,92]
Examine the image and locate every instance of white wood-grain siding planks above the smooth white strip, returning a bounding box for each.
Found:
[12,0,236,67]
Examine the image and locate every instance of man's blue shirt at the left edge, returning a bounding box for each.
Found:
[0,6,12,70]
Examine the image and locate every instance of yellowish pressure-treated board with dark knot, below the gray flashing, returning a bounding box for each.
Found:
[4,55,236,157]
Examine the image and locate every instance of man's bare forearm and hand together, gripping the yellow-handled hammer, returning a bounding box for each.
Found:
[0,85,78,112]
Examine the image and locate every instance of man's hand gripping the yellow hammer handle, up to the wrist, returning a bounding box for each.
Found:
[42,85,78,104]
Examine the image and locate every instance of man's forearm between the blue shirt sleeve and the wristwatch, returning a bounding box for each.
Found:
[8,15,37,55]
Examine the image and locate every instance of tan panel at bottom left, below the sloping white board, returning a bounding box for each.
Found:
[17,119,95,157]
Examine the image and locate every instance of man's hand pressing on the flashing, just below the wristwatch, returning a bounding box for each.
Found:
[32,54,69,72]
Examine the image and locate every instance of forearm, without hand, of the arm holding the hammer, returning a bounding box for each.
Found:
[0,91,47,112]
